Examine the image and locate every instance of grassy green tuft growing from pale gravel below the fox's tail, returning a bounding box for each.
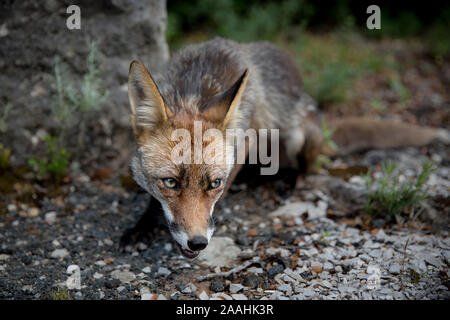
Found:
[364,161,434,216]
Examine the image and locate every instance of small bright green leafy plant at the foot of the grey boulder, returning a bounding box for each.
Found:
[28,136,70,180]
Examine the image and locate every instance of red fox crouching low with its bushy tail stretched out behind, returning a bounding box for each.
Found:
[122,38,449,259]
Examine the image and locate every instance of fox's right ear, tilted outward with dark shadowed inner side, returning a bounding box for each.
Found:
[203,69,248,130]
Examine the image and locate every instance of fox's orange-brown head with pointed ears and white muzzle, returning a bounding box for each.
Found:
[128,61,248,259]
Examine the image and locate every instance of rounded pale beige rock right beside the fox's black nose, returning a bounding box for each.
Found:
[198,237,241,268]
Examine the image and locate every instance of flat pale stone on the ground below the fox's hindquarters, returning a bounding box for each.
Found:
[269,200,328,219]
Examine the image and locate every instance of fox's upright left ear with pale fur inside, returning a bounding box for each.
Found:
[128,61,173,135]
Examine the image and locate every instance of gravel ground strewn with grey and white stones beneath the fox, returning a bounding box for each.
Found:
[0,149,450,300]
